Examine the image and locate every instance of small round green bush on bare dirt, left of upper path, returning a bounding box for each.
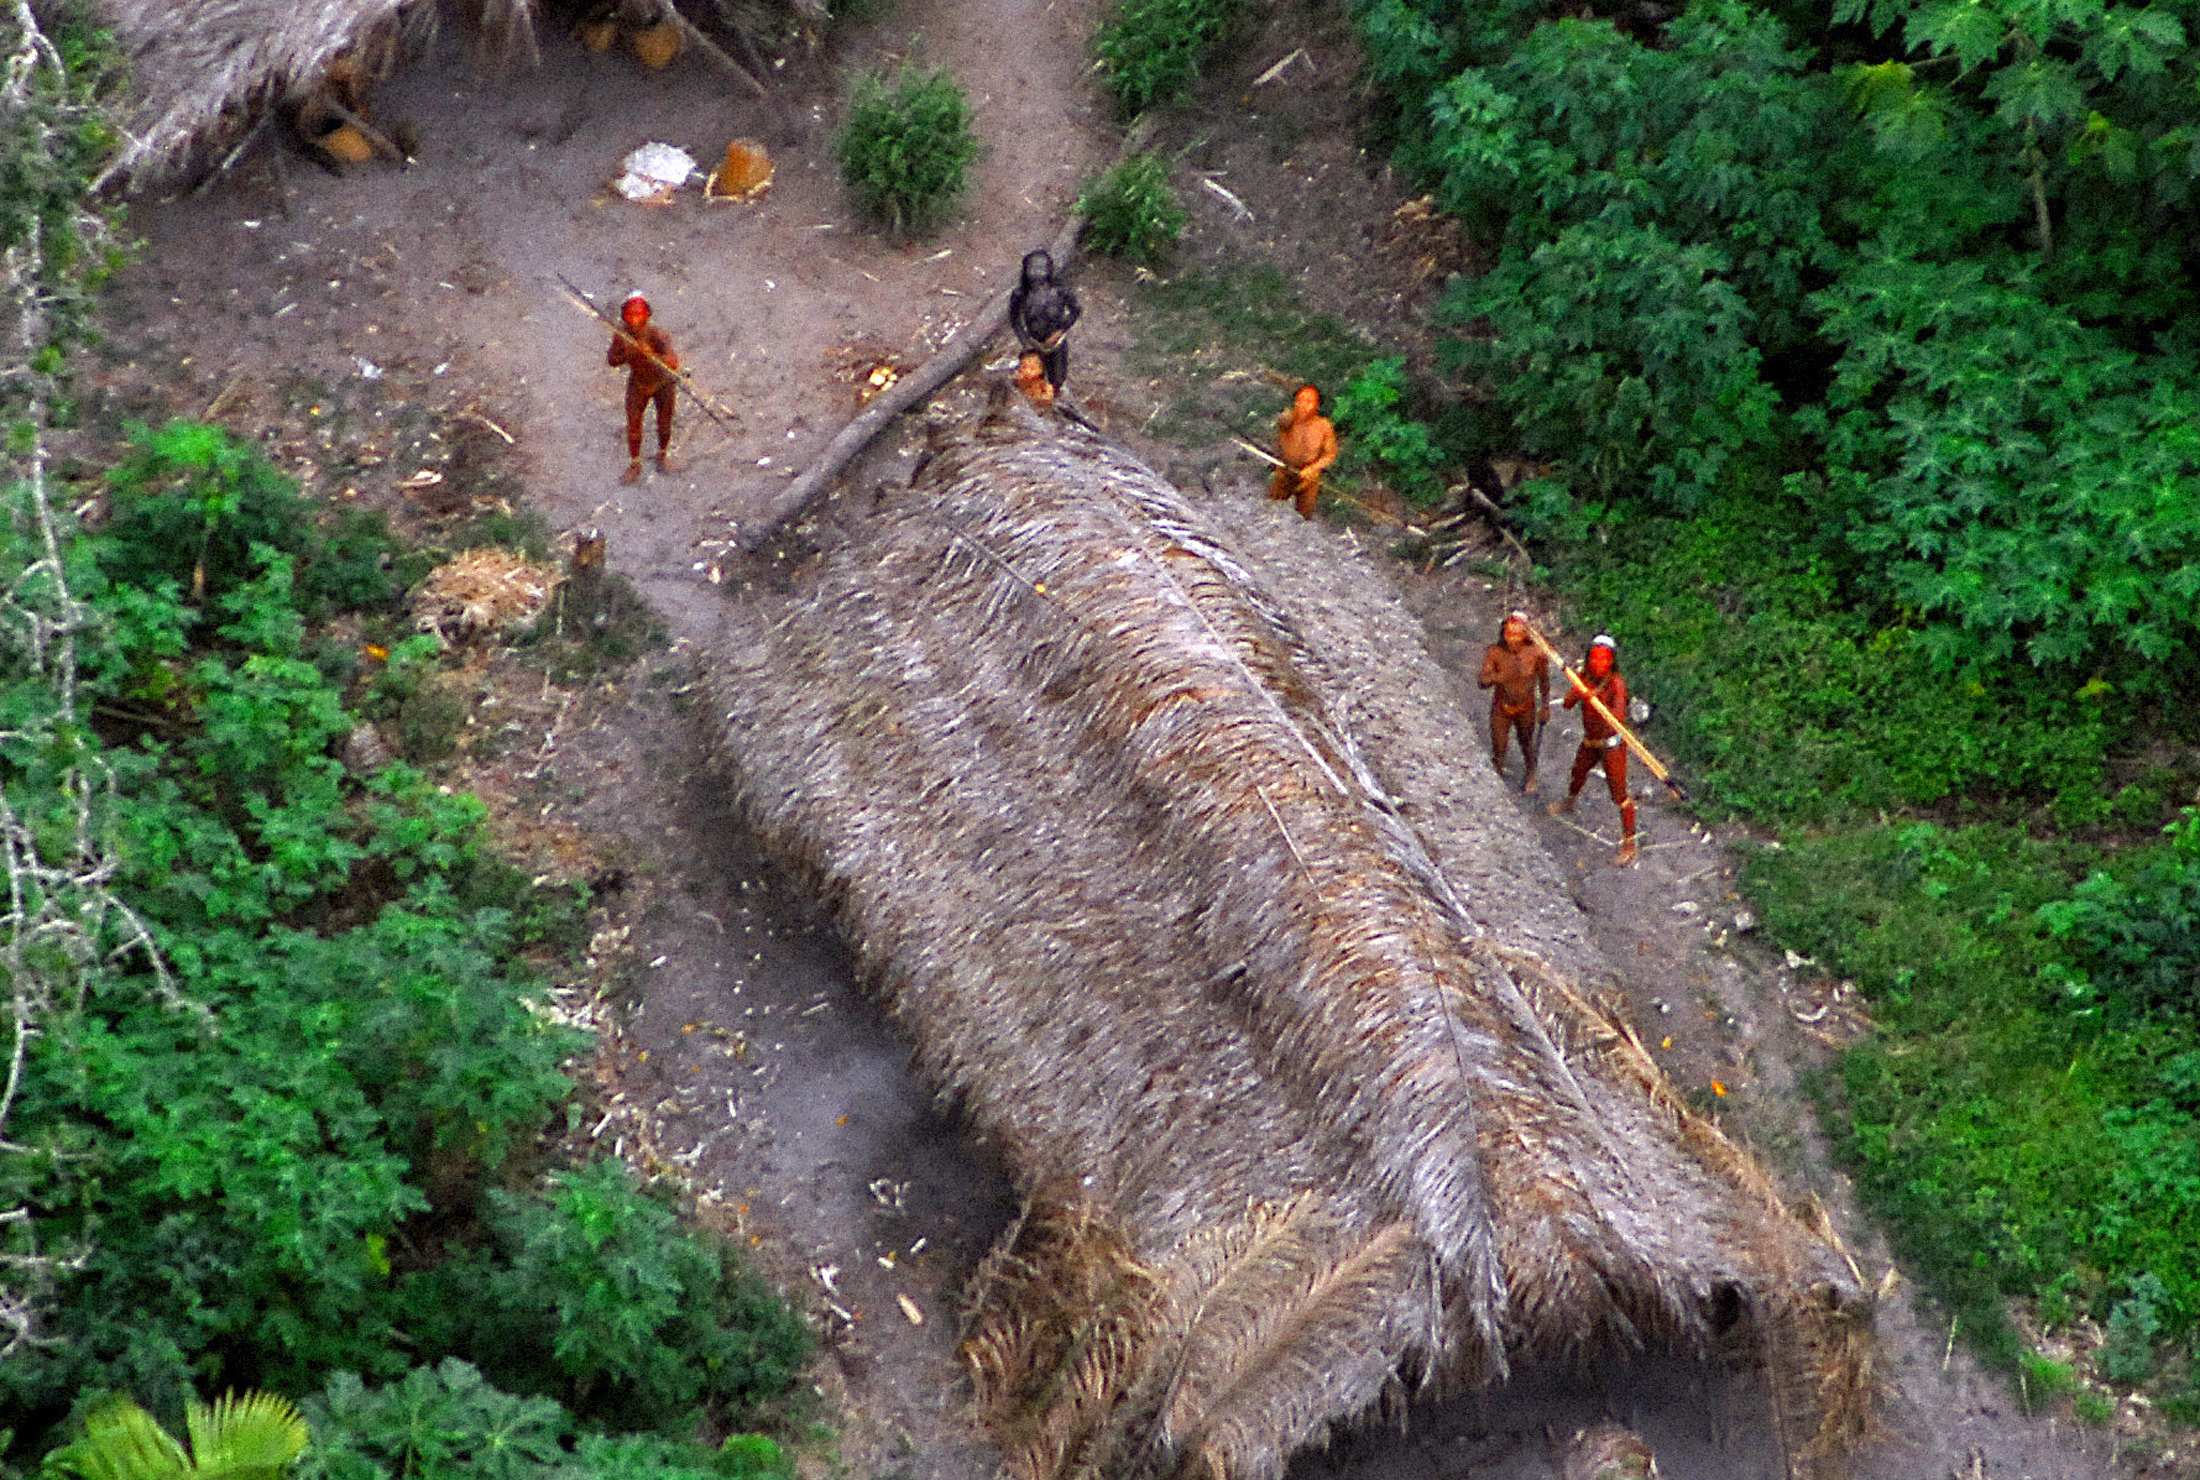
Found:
[834,62,979,235]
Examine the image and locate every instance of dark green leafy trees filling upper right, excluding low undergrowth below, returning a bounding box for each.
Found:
[1355,0,2200,691]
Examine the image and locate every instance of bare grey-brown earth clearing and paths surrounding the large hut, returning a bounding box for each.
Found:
[108,0,2164,1480]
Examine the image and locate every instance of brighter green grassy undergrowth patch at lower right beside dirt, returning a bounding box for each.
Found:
[1745,814,2200,1399]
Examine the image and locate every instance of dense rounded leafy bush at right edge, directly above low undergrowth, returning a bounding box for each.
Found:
[1813,257,2200,691]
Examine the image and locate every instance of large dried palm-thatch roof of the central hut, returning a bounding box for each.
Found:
[724,391,1870,1480]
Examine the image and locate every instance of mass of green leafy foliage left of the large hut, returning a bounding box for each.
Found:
[0,422,807,1473]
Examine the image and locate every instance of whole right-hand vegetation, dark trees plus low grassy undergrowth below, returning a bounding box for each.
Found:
[1351,0,2200,1389]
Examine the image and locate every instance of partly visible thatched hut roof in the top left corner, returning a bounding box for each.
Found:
[95,0,537,180]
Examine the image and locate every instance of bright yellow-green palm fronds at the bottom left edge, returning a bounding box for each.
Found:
[44,1392,310,1480]
